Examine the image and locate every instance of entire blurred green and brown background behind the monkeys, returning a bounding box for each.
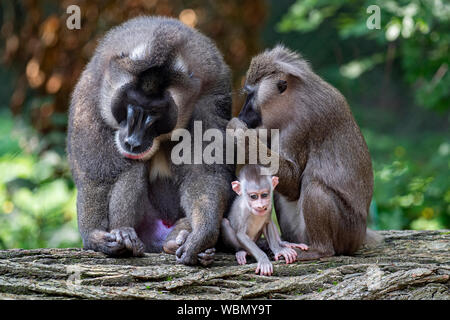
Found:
[0,0,450,249]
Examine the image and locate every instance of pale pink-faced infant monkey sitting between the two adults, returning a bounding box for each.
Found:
[221,165,308,276]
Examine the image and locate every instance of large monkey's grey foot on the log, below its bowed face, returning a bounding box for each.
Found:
[108,227,145,257]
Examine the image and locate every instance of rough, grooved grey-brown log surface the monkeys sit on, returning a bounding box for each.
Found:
[0,230,450,300]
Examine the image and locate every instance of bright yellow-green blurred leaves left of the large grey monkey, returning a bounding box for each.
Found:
[0,111,81,249]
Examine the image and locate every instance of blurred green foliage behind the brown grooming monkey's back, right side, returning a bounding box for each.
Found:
[272,0,450,229]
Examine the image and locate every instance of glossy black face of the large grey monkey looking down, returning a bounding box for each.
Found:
[112,70,178,160]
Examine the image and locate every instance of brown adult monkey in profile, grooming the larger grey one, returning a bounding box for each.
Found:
[228,46,379,260]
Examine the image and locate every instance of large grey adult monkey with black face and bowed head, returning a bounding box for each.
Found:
[67,17,234,264]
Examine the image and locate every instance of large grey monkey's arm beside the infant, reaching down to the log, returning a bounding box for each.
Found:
[175,94,235,265]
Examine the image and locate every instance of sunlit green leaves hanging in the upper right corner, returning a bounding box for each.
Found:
[278,0,450,110]
